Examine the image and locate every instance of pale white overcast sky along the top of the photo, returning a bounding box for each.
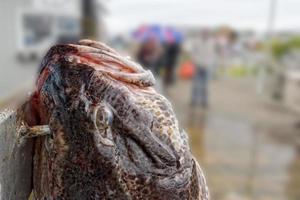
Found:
[105,0,300,33]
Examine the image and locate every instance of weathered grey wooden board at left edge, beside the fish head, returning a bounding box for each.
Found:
[0,111,33,200]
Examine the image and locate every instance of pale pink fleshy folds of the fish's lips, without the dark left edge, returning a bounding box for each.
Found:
[69,39,155,87]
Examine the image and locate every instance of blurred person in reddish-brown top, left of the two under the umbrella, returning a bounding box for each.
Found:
[137,37,164,93]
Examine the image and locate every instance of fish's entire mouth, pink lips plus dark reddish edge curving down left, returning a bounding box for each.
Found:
[38,39,155,88]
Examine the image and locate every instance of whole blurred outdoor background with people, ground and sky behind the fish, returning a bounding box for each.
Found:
[0,0,300,200]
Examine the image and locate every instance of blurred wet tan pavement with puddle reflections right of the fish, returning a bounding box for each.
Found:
[169,80,300,200]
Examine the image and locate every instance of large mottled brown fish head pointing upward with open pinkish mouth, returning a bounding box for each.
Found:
[30,40,208,200]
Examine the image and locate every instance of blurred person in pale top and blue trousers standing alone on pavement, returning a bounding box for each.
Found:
[187,30,215,108]
